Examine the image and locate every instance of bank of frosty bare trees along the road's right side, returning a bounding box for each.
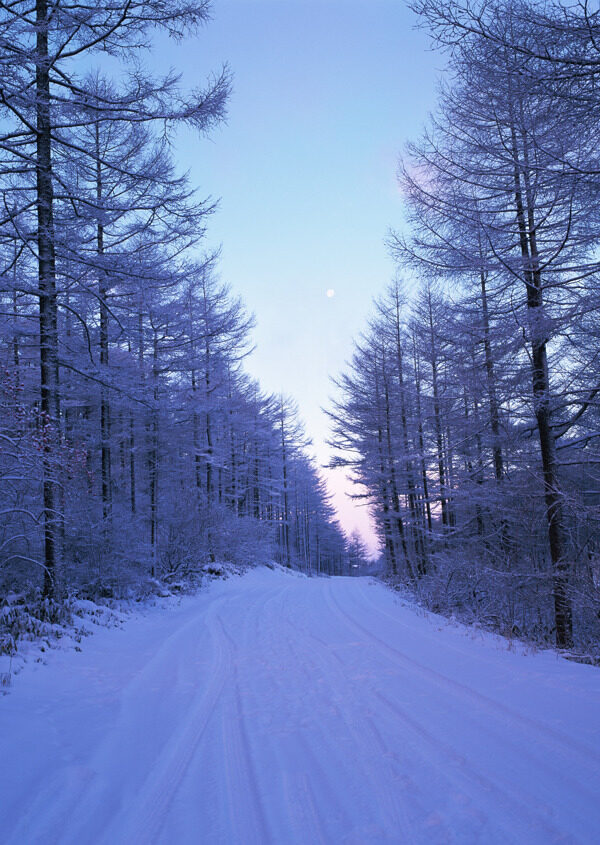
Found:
[331,0,600,649]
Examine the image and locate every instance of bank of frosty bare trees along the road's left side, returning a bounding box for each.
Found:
[0,0,346,599]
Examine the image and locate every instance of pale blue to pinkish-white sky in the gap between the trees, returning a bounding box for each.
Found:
[153,0,440,552]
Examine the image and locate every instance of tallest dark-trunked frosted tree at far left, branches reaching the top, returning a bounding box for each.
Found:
[0,0,227,595]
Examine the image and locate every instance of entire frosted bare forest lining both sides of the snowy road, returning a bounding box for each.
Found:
[0,0,600,654]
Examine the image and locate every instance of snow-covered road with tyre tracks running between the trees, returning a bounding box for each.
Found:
[0,568,600,845]
